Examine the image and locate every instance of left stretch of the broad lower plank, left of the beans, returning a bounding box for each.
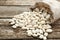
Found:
[0,26,31,39]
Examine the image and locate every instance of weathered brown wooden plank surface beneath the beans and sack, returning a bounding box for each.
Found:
[0,0,60,40]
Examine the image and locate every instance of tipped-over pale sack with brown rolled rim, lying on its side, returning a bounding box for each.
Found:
[30,0,60,23]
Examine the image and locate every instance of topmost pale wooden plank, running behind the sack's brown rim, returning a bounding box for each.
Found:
[0,0,41,5]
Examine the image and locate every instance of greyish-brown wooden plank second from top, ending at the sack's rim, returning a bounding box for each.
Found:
[0,5,31,18]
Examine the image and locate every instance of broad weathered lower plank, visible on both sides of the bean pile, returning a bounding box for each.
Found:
[0,26,60,39]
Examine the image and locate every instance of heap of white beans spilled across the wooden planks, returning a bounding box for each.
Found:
[11,11,52,40]
